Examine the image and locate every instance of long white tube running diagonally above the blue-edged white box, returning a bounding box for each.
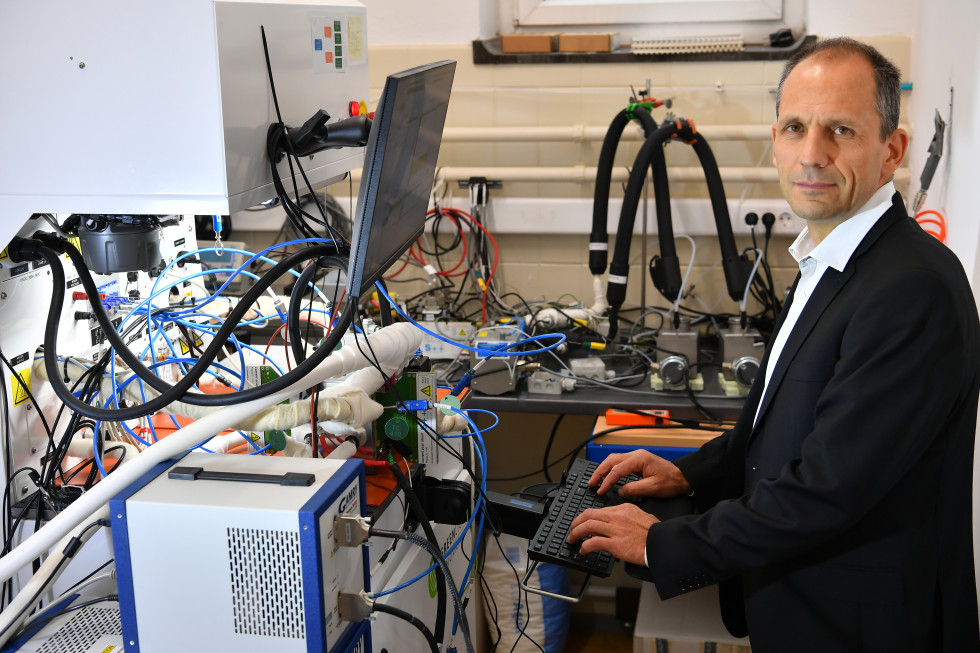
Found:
[0,323,422,588]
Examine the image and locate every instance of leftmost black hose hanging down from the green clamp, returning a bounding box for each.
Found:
[589,105,666,274]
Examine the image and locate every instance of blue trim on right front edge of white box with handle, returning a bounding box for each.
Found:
[298,459,365,653]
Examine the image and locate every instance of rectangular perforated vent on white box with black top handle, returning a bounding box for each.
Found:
[228,528,306,639]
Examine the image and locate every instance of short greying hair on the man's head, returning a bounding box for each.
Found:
[776,37,902,141]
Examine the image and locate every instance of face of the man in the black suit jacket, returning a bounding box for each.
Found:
[772,54,907,228]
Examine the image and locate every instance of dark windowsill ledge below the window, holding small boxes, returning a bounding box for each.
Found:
[473,35,817,64]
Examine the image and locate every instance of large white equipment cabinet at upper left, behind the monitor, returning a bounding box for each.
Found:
[0,0,370,224]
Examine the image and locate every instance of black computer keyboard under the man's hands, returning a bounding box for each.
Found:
[527,458,641,578]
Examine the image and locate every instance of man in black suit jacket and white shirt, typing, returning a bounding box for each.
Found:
[569,39,980,653]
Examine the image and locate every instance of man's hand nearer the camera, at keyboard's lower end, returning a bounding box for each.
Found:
[568,503,660,566]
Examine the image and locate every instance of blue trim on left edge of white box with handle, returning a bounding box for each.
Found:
[109,451,187,653]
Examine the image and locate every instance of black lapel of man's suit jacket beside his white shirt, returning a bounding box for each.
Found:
[750,193,908,438]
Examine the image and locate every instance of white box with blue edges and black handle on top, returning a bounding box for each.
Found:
[109,453,371,653]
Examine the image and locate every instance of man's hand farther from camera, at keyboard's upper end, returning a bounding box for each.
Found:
[589,449,691,499]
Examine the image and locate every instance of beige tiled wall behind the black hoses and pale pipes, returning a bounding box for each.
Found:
[239,37,910,318]
